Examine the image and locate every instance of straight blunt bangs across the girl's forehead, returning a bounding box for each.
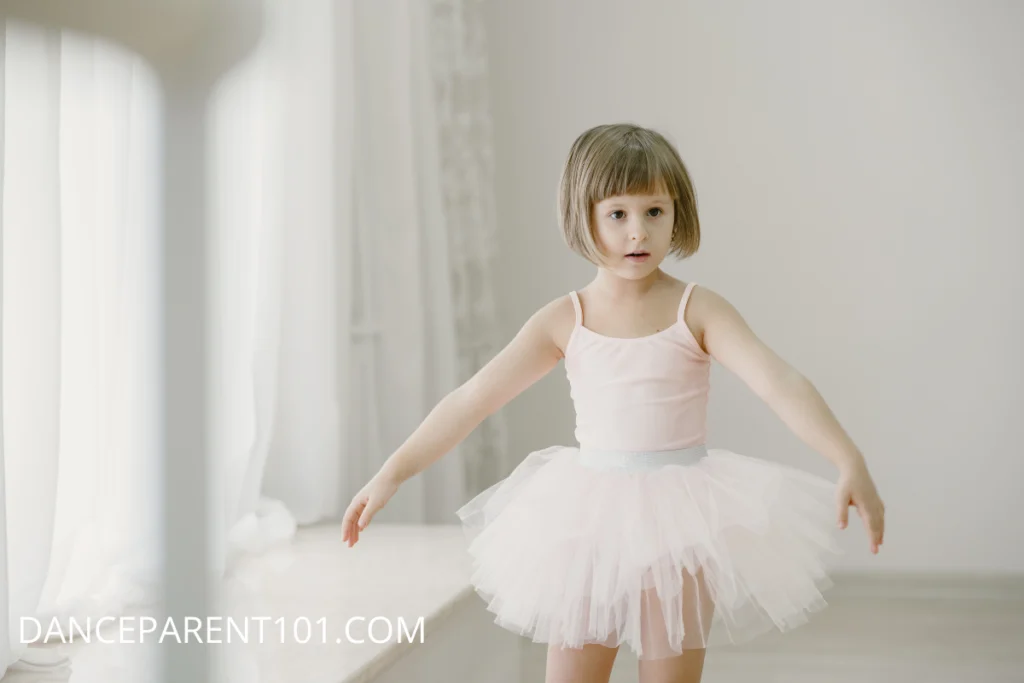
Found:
[588,136,678,202]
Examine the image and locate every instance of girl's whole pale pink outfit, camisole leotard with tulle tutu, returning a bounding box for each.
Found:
[457,283,839,659]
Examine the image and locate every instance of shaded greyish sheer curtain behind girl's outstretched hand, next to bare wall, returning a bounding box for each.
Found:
[341,0,513,523]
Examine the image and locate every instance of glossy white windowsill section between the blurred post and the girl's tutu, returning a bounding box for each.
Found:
[231,523,476,683]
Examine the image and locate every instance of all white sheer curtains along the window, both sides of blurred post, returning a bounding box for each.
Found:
[0,0,512,672]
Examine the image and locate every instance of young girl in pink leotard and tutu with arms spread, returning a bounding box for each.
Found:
[343,125,885,683]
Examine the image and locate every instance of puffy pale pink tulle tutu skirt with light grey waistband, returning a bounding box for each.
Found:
[457,445,839,659]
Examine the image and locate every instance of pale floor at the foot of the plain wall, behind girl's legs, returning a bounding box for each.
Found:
[526,580,1024,683]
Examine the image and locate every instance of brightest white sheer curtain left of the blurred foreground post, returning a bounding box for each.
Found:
[0,25,159,666]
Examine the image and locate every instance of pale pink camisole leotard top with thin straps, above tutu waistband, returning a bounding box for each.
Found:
[565,283,711,451]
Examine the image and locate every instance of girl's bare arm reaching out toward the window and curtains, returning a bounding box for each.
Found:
[342,297,574,546]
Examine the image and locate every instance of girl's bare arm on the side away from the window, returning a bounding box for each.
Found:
[685,288,885,553]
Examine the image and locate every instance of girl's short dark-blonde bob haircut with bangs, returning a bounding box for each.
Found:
[558,123,700,265]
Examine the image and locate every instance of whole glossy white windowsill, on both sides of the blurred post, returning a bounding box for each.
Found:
[3,522,475,683]
